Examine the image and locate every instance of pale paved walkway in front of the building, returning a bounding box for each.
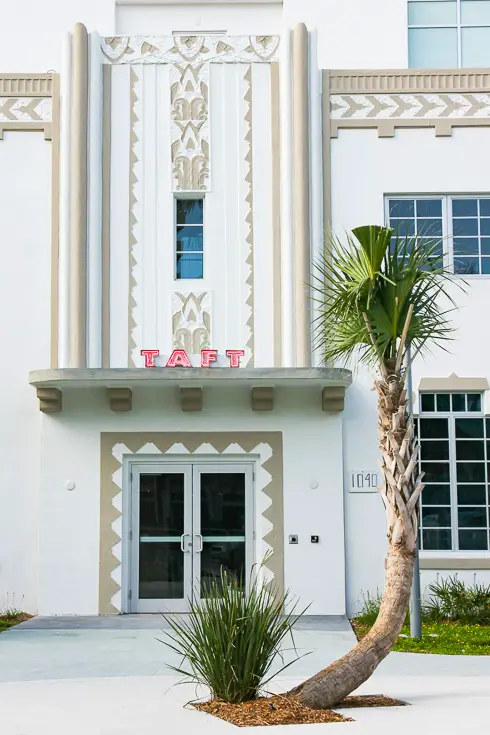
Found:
[0,616,490,735]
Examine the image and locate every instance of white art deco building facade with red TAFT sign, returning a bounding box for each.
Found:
[0,0,490,615]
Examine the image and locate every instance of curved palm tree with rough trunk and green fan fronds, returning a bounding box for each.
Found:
[291,226,462,709]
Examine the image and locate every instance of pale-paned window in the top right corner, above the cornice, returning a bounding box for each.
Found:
[408,0,490,68]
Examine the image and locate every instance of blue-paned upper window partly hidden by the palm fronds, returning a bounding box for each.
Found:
[386,196,490,276]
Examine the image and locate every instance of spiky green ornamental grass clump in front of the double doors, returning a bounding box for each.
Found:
[161,569,305,704]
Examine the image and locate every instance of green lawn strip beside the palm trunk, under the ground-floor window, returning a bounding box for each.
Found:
[351,620,490,656]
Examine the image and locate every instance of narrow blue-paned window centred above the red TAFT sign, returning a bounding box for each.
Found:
[175,199,204,278]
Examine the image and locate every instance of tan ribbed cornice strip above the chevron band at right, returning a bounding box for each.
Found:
[329,69,490,94]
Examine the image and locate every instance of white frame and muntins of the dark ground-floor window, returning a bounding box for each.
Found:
[414,390,490,556]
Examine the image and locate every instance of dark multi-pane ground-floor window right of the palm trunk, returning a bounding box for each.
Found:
[416,393,490,551]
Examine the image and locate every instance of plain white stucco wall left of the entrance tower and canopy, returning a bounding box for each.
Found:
[0,132,51,612]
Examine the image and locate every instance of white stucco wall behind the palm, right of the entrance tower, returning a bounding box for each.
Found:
[332,128,490,609]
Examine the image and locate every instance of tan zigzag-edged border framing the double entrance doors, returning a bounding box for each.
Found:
[99,432,284,614]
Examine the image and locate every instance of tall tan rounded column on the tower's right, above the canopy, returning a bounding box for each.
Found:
[292,23,311,367]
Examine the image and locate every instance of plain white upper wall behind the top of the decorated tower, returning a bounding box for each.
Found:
[0,0,408,72]
